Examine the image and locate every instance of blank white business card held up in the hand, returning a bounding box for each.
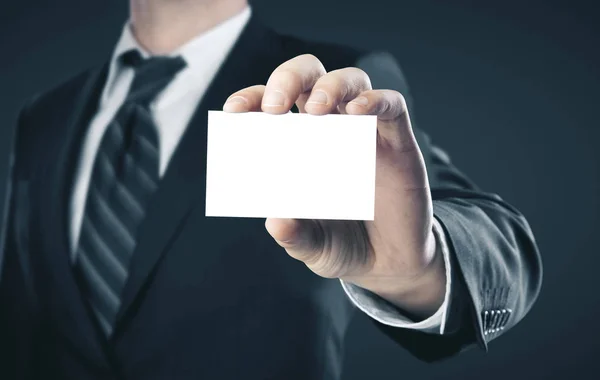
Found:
[206,111,377,220]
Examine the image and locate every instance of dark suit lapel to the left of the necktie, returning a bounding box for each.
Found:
[36,66,113,362]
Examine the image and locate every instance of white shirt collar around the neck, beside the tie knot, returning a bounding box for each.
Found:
[102,6,252,104]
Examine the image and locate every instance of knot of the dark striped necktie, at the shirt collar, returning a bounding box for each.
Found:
[121,50,187,106]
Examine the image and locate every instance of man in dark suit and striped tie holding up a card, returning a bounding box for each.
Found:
[0,0,542,379]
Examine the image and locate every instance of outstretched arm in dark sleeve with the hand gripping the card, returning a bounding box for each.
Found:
[223,54,541,360]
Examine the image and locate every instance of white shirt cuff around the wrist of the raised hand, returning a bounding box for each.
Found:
[340,217,452,334]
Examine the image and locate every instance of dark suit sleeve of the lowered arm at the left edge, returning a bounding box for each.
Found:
[0,102,42,379]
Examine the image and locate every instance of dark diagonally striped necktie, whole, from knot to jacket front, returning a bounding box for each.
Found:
[75,50,186,336]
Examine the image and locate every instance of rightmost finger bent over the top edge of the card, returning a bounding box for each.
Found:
[346,90,418,151]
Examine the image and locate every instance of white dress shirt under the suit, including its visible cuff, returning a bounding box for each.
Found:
[70,7,450,334]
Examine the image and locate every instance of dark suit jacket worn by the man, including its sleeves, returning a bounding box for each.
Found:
[0,14,541,380]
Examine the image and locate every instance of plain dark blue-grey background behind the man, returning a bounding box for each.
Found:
[0,0,600,380]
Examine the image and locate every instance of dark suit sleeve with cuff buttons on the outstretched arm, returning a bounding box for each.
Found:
[357,53,542,361]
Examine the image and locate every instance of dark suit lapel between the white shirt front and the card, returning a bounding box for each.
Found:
[115,14,281,330]
